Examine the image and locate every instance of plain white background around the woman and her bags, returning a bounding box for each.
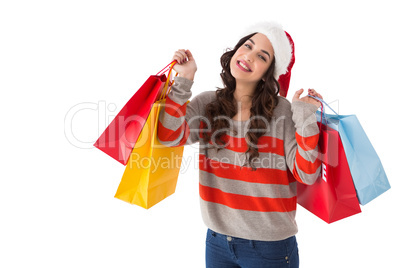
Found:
[0,0,402,268]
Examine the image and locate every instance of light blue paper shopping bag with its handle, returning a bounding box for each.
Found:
[310,98,391,205]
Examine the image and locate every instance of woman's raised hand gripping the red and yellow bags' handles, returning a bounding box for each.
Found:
[172,49,197,80]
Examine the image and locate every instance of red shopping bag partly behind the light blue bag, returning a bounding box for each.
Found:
[297,122,361,223]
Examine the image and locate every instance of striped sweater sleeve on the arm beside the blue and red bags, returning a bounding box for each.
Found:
[285,101,321,185]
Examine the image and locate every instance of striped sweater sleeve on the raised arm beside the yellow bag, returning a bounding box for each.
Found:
[157,77,201,147]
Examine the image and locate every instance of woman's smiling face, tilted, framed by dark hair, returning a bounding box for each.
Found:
[230,33,274,84]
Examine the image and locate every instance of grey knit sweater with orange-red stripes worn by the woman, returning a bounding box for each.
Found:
[158,77,321,241]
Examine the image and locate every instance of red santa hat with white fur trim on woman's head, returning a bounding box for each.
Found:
[244,21,295,97]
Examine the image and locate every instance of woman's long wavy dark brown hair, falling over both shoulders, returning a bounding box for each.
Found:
[203,33,279,170]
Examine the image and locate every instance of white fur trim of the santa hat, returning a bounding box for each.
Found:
[243,21,292,80]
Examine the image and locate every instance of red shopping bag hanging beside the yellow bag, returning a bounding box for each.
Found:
[94,61,176,165]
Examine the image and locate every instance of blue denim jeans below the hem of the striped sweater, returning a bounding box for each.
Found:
[205,229,299,268]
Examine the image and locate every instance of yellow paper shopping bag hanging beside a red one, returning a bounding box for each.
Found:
[115,100,184,209]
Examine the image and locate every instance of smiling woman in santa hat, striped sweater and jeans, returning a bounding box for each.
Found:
[158,22,321,268]
